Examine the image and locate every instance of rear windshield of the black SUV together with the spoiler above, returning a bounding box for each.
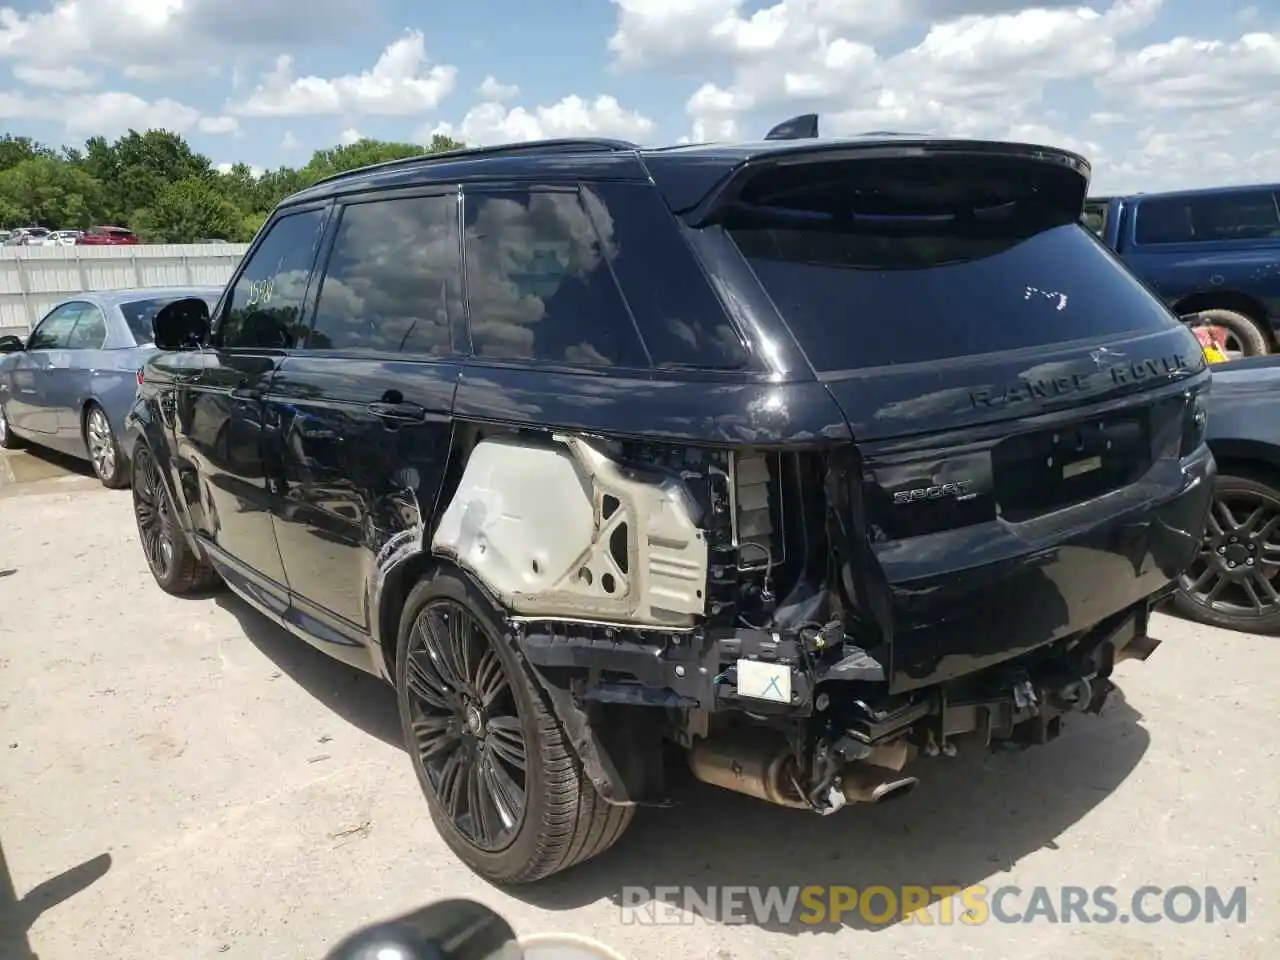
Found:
[724,157,1176,371]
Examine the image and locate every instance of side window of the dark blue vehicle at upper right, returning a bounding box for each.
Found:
[1134,189,1280,244]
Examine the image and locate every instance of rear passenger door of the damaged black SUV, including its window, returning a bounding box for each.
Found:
[268,188,463,666]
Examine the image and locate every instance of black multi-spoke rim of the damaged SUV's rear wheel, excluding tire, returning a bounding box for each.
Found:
[406,598,529,852]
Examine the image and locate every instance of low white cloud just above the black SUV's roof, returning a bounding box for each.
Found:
[427,96,654,146]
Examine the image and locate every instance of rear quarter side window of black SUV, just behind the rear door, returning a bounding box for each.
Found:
[465,189,649,367]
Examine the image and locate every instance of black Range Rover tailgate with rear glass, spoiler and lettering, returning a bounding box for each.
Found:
[718,142,1207,689]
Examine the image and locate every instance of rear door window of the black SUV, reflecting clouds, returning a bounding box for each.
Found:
[307,193,462,356]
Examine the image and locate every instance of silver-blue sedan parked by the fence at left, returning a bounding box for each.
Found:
[0,287,221,488]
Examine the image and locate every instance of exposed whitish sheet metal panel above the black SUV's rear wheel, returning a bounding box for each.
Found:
[431,436,707,627]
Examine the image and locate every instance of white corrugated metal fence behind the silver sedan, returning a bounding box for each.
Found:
[0,243,248,337]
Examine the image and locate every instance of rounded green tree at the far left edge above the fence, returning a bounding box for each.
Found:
[0,156,104,230]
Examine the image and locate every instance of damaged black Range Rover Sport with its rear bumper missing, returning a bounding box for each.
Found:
[128,118,1215,883]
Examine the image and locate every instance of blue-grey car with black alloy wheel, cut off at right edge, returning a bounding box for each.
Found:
[1174,356,1280,632]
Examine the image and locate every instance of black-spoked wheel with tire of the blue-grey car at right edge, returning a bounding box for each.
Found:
[1174,474,1280,632]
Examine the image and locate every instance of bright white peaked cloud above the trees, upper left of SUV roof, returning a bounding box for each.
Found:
[233,31,457,116]
